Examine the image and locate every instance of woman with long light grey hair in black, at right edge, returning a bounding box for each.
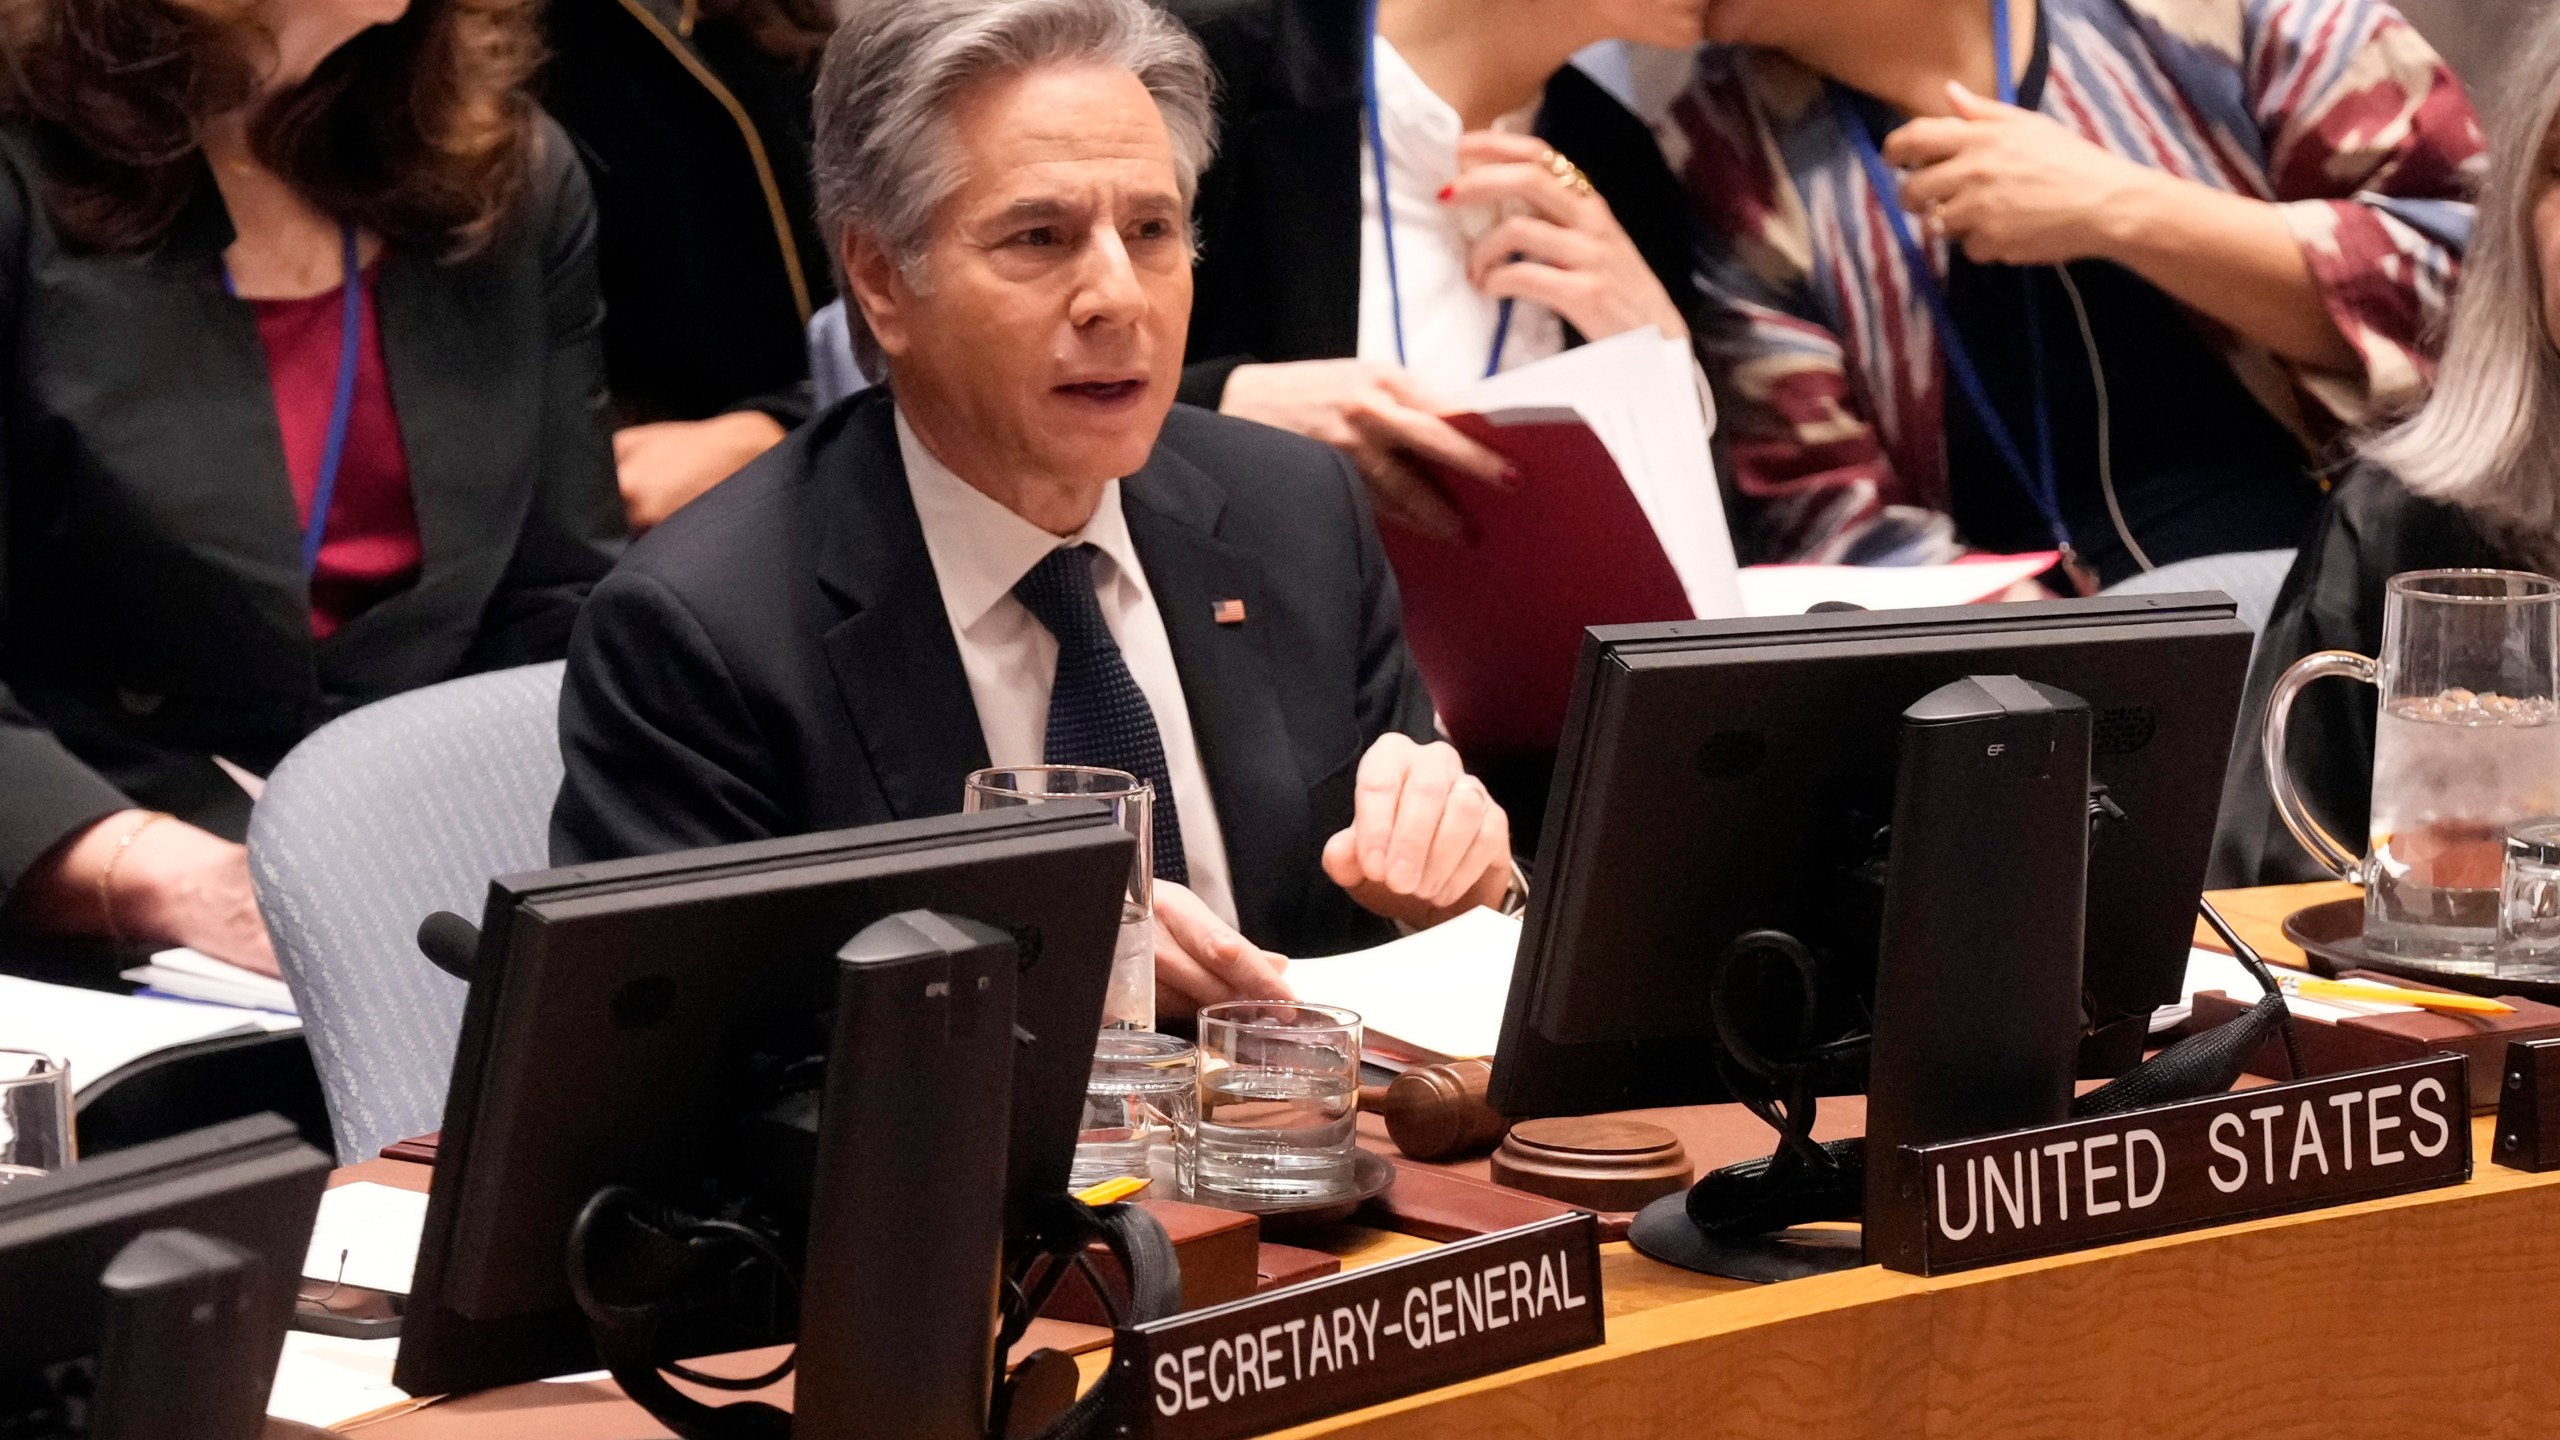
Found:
[2209,8,2560,887]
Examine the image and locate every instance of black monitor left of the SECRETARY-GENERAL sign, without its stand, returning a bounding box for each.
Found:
[394,802,1134,1394]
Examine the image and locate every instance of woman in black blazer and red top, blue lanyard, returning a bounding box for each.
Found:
[0,0,622,974]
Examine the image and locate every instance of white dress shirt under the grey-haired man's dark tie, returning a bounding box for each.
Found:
[896,413,1236,925]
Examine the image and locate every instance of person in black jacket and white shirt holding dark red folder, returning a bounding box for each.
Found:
[1167,0,1708,533]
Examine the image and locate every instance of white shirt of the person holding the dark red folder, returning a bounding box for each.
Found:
[1359,36,1564,395]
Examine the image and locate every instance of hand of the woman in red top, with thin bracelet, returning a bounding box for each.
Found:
[13,810,276,976]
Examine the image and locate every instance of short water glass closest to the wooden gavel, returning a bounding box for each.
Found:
[1198,999,1359,1202]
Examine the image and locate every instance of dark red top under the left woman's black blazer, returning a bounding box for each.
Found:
[251,269,422,641]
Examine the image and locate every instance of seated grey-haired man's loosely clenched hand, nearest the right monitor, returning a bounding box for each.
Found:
[1324,733,1510,925]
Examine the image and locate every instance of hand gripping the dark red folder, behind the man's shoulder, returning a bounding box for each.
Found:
[1219,359,1518,541]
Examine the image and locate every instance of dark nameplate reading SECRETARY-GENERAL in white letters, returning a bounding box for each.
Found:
[1111,1215,1600,1440]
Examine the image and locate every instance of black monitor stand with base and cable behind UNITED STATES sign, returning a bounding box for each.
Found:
[1628,676,2092,1281]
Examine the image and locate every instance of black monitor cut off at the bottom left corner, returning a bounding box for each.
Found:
[0,1115,330,1435]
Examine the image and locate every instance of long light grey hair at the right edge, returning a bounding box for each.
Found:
[2363,8,2560,569]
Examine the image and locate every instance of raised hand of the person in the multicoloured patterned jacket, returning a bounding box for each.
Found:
[1884,85,2181,264]
